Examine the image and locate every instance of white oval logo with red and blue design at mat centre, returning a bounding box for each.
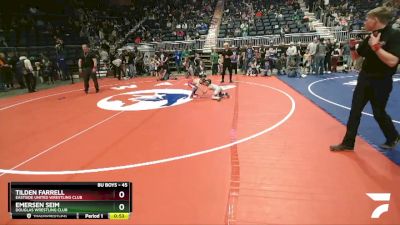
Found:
[97,89,192,111]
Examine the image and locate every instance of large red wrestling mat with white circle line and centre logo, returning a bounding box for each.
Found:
[0,76,400,224]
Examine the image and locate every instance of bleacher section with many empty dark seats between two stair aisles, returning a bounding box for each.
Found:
[219,0,310,38]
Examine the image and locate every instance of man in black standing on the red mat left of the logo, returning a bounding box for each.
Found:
[78,44,100,94]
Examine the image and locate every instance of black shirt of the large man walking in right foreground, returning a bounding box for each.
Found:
[357,25,400,79]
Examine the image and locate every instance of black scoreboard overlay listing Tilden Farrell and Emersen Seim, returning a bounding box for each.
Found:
[8,182,132,219]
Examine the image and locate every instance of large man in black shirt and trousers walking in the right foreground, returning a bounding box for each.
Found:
[330,7,400,151]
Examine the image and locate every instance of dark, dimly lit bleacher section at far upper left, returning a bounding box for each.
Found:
[0,0,147,47]
